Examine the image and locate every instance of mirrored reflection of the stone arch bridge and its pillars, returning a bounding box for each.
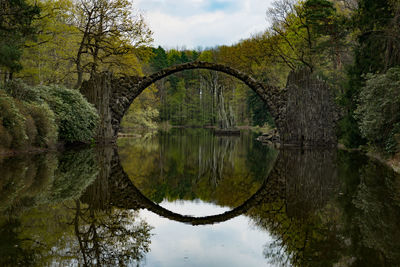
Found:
[82,148,337,225]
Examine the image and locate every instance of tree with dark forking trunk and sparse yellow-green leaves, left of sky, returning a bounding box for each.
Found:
[74,0,152,88]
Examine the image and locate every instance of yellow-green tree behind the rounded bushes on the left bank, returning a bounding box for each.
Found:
[18,0,80,88]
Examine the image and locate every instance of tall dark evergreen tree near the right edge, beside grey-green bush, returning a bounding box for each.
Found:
[340,0,400,147]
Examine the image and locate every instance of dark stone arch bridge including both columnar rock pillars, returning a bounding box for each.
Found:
[81,61,337,147]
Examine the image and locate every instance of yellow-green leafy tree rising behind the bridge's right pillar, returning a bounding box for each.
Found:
[267,0,348,71]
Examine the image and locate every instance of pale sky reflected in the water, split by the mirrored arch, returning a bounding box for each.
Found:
[140,201,272,266]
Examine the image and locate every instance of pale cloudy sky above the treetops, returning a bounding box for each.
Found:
[133,0,273,49]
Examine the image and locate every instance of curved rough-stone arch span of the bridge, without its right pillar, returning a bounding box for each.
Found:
[81,61,286,138]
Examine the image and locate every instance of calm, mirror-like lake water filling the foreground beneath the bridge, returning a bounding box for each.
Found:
[0,129,400,266]
